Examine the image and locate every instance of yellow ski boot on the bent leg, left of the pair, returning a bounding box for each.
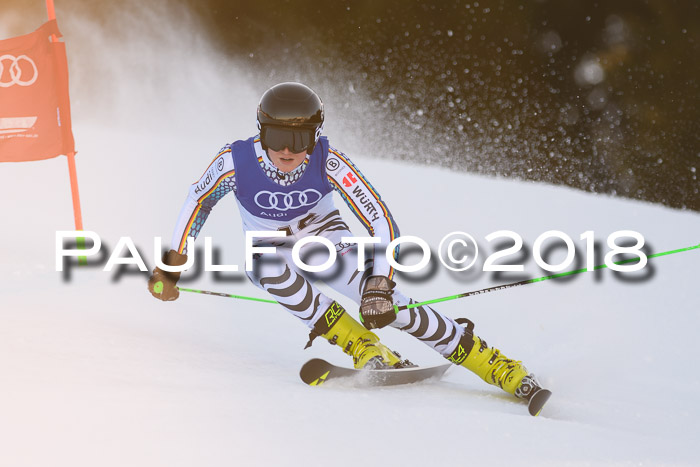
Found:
[306,302,414,369]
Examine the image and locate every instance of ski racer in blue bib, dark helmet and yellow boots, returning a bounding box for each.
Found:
[148,82,540,410]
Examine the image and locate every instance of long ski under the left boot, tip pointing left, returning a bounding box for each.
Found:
[299,358,452,387]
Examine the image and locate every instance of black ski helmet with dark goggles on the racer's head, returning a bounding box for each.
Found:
[258,82,323,154]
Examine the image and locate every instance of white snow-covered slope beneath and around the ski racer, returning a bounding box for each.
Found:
[0,5,700,467]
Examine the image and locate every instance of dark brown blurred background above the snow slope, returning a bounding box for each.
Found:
[5,0,700,211]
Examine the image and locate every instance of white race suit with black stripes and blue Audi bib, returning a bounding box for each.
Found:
[172,137,464,356]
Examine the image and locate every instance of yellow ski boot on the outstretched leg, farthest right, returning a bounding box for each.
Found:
[446,318,541,401]
